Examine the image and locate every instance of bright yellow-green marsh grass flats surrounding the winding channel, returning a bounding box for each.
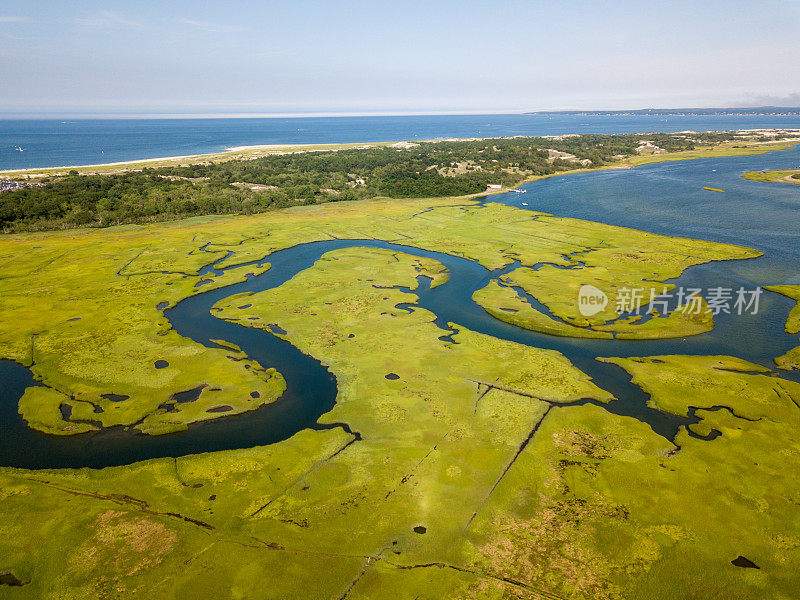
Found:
[0,180,800,600]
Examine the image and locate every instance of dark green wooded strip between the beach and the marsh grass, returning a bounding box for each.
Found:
[0,133,752,232]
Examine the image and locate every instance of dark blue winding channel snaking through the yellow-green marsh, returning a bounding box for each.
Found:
[0,146,797,469]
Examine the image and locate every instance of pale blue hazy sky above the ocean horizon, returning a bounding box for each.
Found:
[0,0,800,114]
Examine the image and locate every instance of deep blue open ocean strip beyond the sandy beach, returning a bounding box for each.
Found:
[0,115,800,170]
